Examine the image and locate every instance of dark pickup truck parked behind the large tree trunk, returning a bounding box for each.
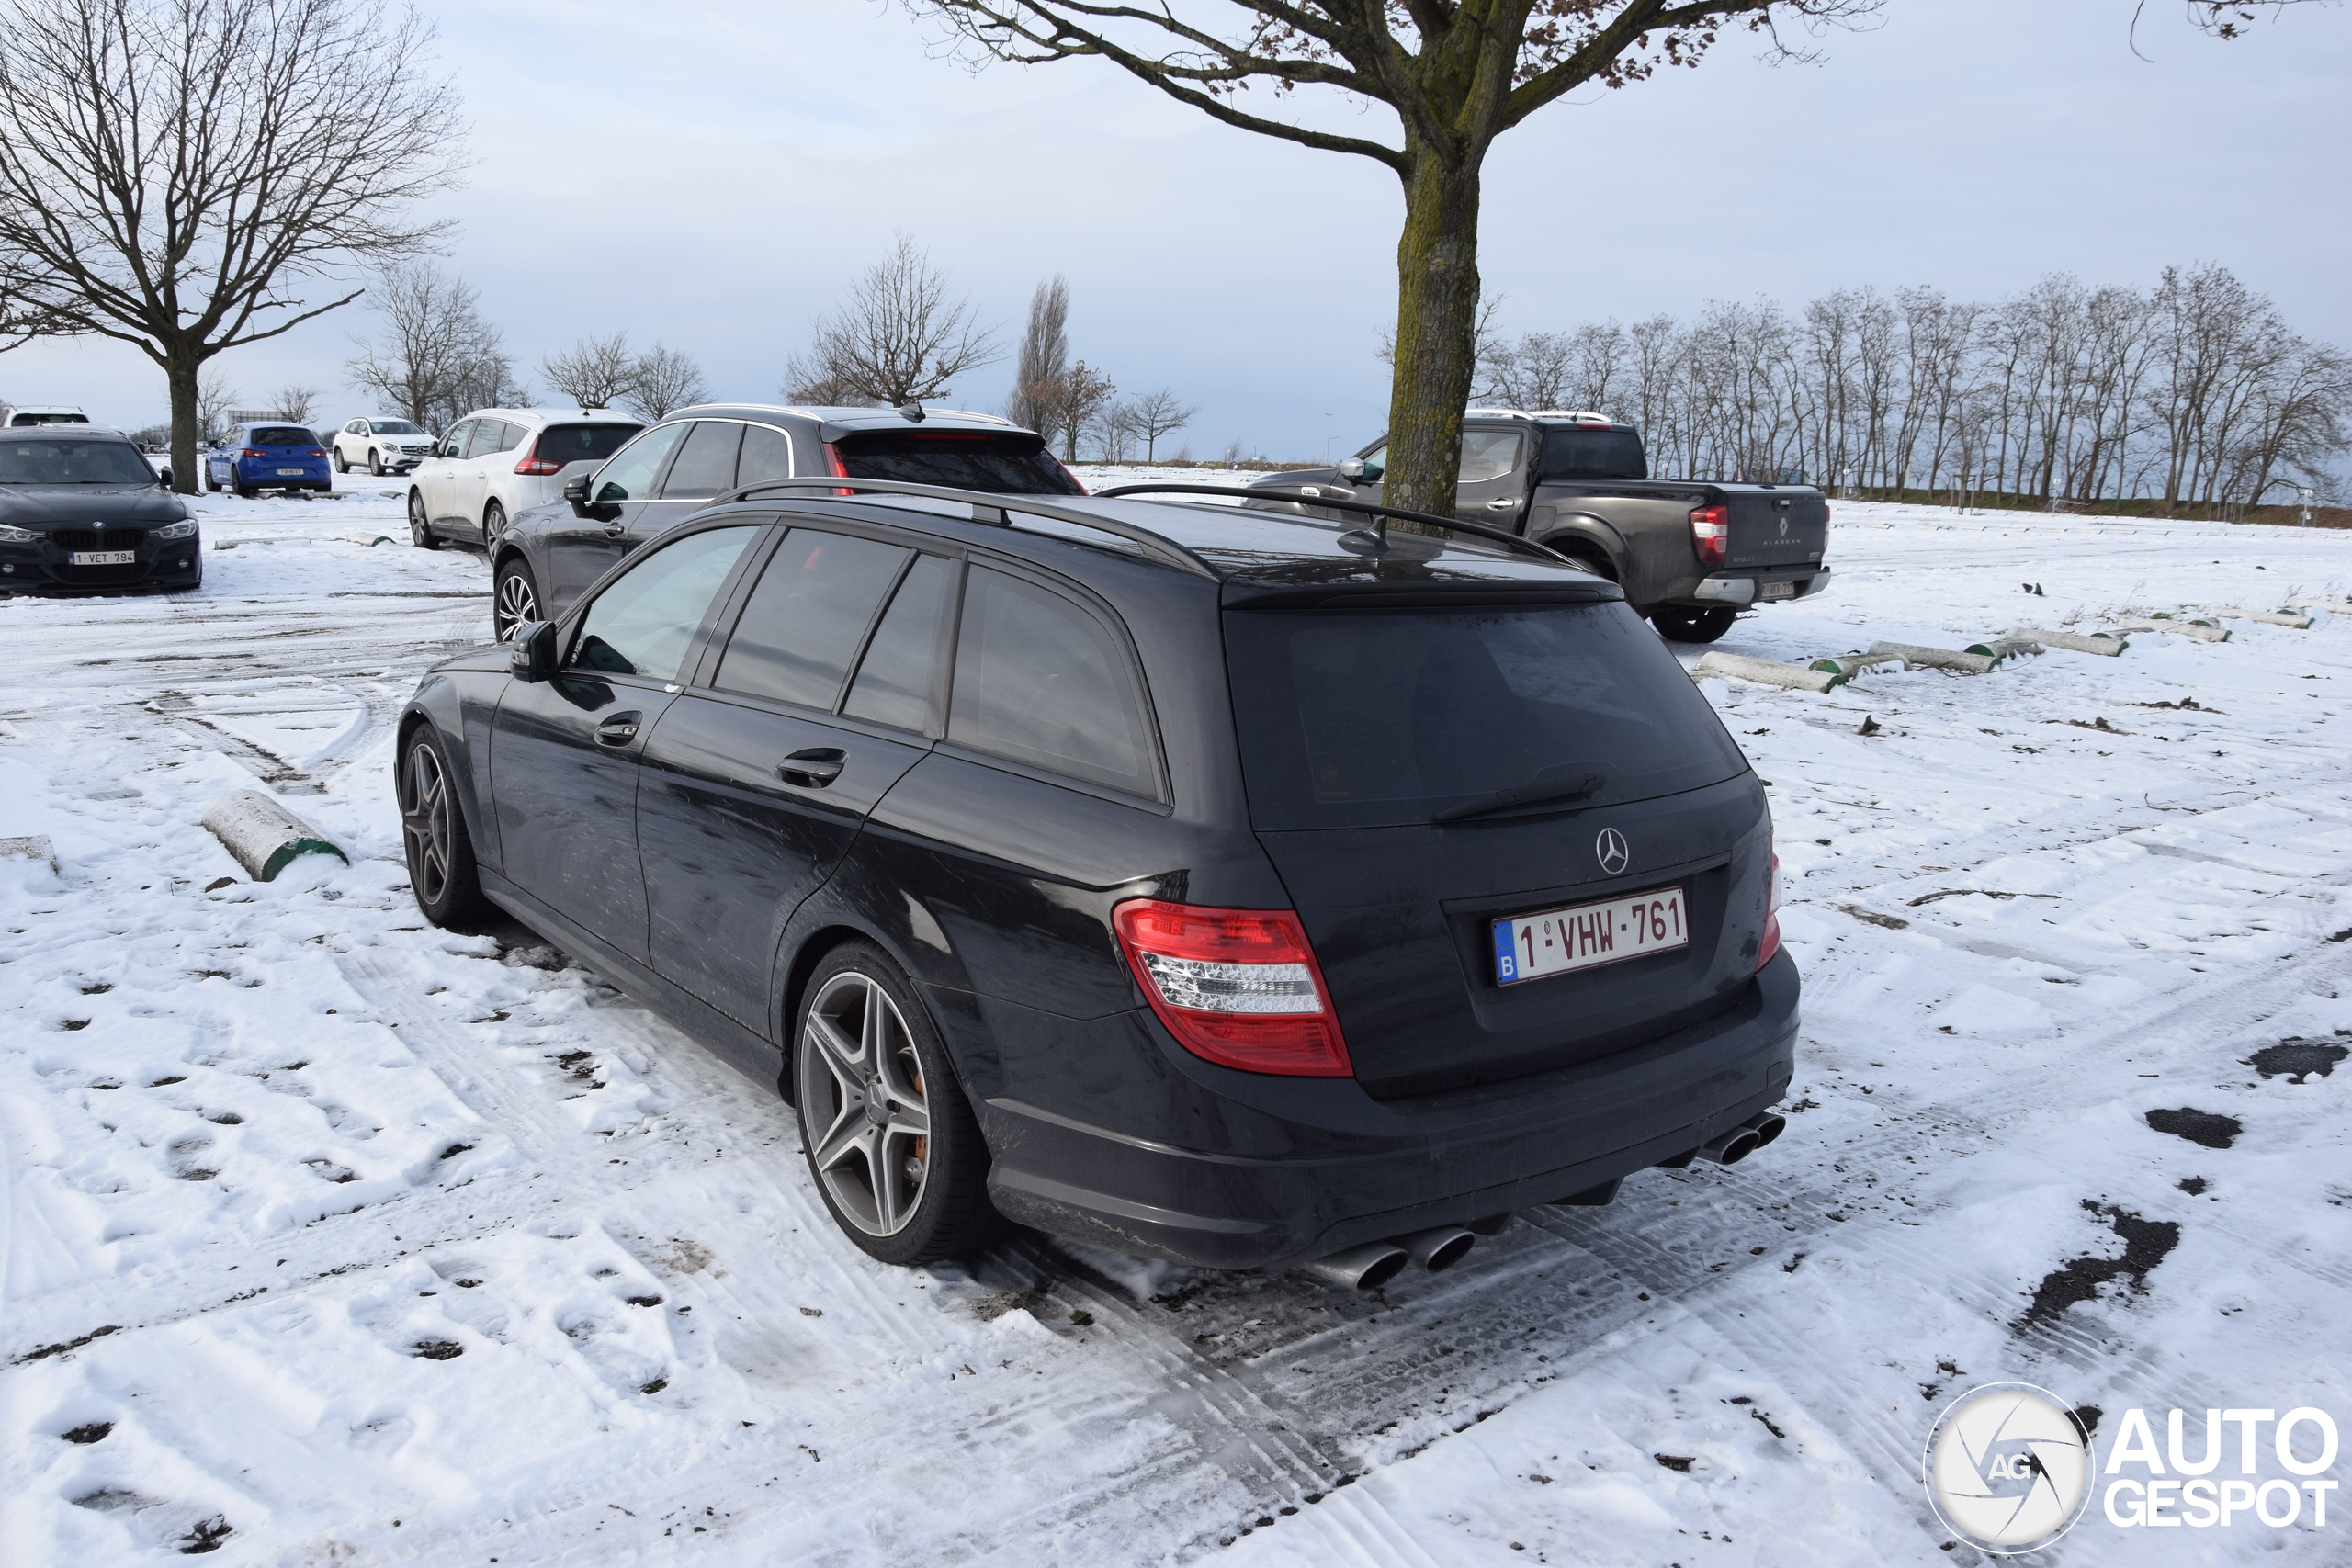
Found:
[1247,409,1830,642]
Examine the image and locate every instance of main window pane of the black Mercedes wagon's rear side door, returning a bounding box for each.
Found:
[713,529,910,712]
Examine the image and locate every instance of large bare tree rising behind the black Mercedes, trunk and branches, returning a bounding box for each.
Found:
[910,0,1877,513]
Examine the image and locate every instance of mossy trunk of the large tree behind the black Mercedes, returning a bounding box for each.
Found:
[1383,148,1479,517]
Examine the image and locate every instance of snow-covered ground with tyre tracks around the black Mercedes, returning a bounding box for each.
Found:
[0,470,2352,1568]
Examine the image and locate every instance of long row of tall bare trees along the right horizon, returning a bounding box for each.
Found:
[1477,264,2352,510]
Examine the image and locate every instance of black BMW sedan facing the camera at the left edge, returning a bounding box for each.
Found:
[0,425,205,590]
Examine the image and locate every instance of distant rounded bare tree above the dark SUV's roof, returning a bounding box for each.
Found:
[788,235,1004,407]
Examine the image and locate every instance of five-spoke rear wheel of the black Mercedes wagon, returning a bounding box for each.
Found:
[793,942,1002,1265]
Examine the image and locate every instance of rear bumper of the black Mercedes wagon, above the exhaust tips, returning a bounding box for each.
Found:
[981,954,1799,1269]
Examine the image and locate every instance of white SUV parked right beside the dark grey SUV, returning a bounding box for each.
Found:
[409,409,644,550]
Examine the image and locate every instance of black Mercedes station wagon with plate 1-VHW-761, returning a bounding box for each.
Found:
[398,479,1797,1286]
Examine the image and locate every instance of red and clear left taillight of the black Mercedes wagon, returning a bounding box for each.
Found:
[1110,898,1355,1079]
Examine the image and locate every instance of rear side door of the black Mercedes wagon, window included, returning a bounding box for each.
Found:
[638,526,957,1032]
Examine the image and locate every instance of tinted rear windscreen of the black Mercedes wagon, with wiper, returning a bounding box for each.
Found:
[1226,604,1747,829]
